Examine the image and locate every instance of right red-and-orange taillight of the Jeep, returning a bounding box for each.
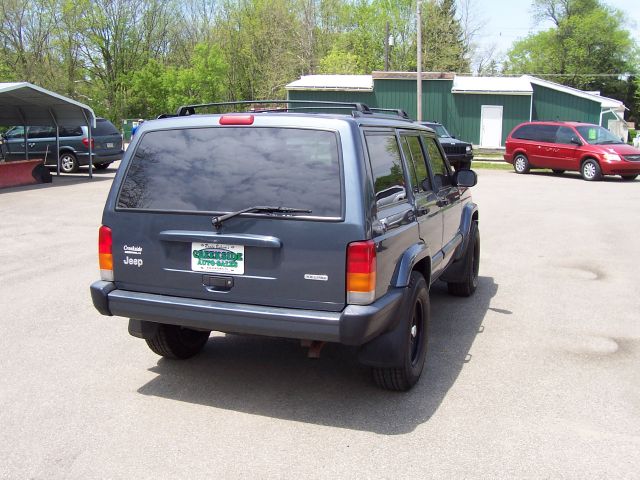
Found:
[347,240,376,305]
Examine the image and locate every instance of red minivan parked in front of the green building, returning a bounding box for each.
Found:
[504,122,640,181]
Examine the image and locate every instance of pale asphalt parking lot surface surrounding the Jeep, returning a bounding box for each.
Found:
[0,170,640,479]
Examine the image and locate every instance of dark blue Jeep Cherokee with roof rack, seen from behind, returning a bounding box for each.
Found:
[91,101,480,390]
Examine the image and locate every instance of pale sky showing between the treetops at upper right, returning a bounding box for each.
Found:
[471,0,640,61]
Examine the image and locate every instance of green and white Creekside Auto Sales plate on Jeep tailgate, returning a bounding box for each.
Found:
[191,242,244,275]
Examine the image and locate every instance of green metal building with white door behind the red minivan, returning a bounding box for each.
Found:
[286,72,627,147]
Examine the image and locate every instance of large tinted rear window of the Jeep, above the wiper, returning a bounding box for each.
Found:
[117,127,342,217]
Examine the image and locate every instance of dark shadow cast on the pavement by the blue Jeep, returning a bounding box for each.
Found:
[138,277,498,435]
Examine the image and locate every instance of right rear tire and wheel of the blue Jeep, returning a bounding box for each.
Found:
[373,271,430,391]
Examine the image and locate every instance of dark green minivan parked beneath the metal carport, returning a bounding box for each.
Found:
[2,118,124,173]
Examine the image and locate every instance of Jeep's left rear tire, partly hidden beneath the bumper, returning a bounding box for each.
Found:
[146,324,211,359]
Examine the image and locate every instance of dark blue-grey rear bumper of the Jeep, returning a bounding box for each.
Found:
[91,281,406,345]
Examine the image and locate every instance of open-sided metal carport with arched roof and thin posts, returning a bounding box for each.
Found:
[0,82,96,178]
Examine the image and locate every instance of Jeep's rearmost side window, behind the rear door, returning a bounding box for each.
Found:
[365,133,407,207]
